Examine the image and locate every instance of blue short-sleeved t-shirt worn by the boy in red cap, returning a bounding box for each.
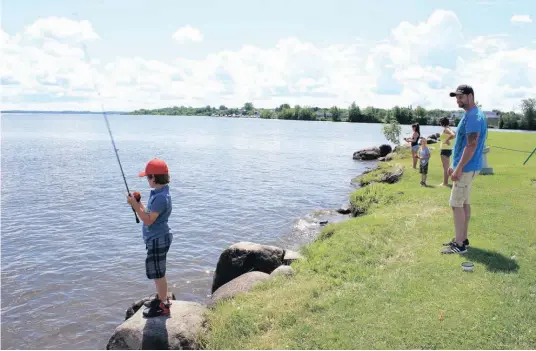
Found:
[142,185,171,243]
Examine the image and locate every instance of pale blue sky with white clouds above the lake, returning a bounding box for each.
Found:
[1,0,536,109]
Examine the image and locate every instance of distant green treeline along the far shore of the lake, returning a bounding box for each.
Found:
[130,99,536,130]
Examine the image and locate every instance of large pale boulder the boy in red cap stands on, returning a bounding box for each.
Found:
[106,300,206,350]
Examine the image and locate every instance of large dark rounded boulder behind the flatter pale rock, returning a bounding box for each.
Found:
[211,242,285,293]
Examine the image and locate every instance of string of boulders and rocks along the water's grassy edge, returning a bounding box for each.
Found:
[106,142,406,350]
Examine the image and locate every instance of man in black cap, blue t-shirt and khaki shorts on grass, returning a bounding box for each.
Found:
[441,84,488,254]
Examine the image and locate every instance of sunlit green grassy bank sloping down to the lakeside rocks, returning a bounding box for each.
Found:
[204,132,536,349]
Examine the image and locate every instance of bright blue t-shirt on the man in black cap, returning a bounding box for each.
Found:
[452,106,488,172]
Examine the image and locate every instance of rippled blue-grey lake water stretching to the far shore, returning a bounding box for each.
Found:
[1,114,444,349]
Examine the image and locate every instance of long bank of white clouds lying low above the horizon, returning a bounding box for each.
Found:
[0,10,536,110]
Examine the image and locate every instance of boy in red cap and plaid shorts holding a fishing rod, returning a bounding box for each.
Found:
[127,158,173,318]
